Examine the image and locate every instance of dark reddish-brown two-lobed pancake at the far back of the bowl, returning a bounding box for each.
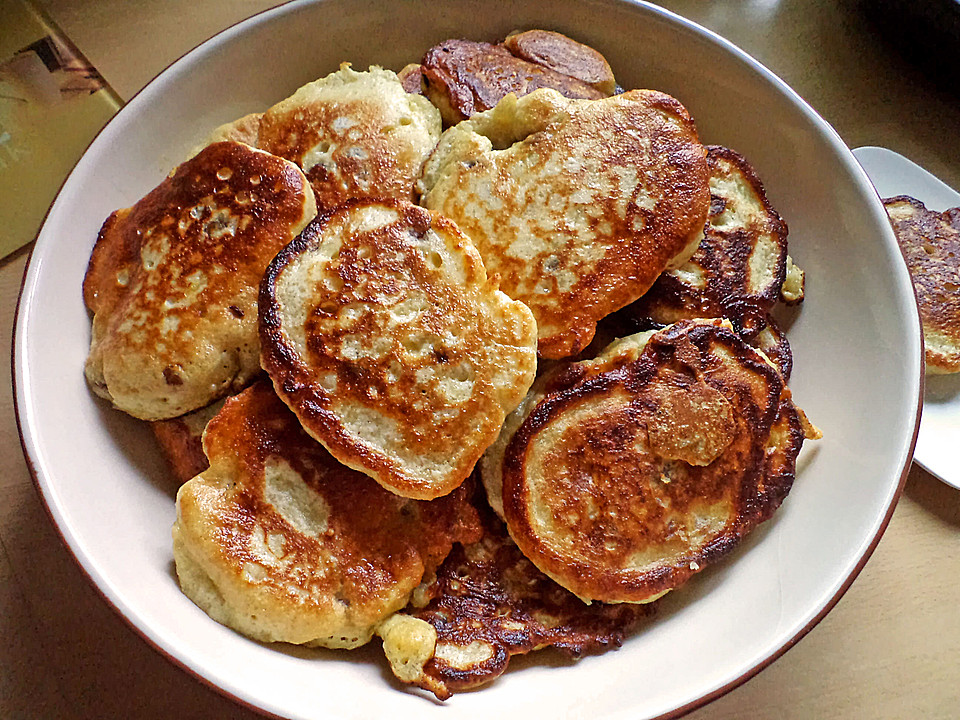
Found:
[419,30,616,126]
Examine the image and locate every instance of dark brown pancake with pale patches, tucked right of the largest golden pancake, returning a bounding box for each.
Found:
[630,145,787,337]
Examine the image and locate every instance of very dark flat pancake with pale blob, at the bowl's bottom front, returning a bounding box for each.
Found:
[377,492,655,699]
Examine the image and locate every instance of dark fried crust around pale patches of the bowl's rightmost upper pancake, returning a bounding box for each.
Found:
[630,145,788,337]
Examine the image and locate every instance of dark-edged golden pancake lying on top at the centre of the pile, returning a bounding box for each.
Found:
[260,200,537,499]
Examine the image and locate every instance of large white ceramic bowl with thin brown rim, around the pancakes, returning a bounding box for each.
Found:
[14,0,922,720]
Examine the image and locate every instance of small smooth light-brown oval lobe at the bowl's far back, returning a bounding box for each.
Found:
[503,30,617,95]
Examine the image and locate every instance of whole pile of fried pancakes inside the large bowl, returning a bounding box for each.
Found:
[83,30,818,698]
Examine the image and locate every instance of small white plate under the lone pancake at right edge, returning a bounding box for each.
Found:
[853,147,960,488]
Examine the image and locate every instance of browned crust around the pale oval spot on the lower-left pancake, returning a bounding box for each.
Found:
[178,381,480,632]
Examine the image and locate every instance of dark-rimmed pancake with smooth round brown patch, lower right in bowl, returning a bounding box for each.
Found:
[481,320,805,602]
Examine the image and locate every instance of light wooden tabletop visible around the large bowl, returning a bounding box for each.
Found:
[0,0,960,720]
